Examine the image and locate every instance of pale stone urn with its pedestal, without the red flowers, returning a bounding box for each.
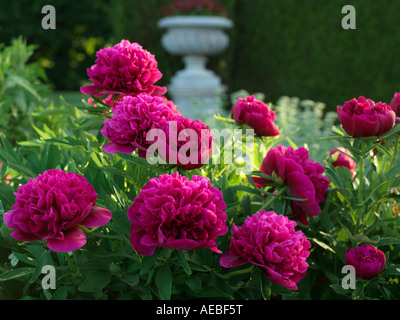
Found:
[158,16,233,120]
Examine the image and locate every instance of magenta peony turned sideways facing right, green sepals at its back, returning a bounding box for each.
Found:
[253,145,329,225]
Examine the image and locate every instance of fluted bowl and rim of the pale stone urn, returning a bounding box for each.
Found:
[158,16,233,56]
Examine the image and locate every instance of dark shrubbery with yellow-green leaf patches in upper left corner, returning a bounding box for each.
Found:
[0,0,112,91]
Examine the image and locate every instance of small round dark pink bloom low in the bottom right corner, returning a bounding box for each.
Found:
[345,244,386,279]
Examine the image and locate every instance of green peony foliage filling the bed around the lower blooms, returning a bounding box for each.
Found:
[0,83,400,300]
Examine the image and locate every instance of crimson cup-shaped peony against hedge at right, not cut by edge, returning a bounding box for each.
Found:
[337,97,396,138]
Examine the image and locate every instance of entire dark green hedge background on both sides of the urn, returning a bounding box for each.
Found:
[0,0,400,110]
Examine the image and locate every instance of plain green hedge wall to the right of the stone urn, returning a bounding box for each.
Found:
[230,0,400,110]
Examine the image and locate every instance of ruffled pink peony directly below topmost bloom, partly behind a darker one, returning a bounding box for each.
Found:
[101,93,174,158]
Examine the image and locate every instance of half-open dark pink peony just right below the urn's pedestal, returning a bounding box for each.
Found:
[231,96,279,137]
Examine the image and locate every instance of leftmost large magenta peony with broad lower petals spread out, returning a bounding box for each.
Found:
[3,169,111,252]
